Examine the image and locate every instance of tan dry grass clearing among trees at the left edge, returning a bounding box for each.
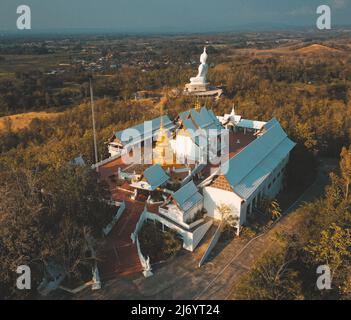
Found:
[0,112,62,133]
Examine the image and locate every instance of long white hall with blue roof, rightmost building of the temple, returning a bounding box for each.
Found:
[202,119,295,225]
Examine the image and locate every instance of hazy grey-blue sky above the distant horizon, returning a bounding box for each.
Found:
[0,0,351,33]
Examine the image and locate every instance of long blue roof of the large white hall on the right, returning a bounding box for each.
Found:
[222,119,295,199]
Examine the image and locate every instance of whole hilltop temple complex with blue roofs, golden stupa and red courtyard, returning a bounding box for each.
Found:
[95,105,295,276]
